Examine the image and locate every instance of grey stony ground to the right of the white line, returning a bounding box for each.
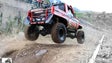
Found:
[96,34,112,63]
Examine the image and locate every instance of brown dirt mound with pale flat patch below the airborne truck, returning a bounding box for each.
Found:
[5,43,76,63]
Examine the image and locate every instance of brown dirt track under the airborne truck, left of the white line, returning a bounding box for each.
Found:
[0,24,101,63]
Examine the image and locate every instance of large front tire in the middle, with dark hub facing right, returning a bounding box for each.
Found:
[51,23,66,43]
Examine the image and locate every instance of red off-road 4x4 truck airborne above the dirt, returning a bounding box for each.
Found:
[25,0,85,44]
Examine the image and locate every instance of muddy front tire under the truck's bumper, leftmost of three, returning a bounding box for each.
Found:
[24,25,39,41]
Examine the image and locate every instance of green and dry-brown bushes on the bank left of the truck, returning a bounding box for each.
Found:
[0,11,25,35]
